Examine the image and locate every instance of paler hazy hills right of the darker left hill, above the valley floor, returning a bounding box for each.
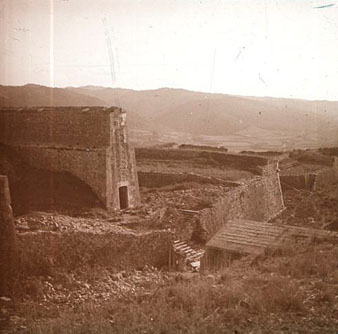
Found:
[70,87,338,140]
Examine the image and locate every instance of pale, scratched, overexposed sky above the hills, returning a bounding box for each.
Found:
[0,0,338,100]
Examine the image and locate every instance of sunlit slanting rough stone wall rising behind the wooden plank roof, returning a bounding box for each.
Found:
[200,162,284,236]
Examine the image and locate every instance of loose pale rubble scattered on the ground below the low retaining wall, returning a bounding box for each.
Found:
[26,266,170,308]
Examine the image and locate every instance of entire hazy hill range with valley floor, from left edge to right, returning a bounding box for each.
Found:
[0,84,338,147]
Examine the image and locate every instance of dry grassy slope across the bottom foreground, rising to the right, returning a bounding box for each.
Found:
[4,243,338,334]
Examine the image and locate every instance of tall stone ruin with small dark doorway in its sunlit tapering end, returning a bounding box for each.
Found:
[0,107,140,209]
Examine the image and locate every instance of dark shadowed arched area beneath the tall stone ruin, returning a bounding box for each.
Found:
[0,146,104,215]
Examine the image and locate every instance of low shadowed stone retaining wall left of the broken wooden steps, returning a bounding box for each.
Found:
[18,231,172,275]
